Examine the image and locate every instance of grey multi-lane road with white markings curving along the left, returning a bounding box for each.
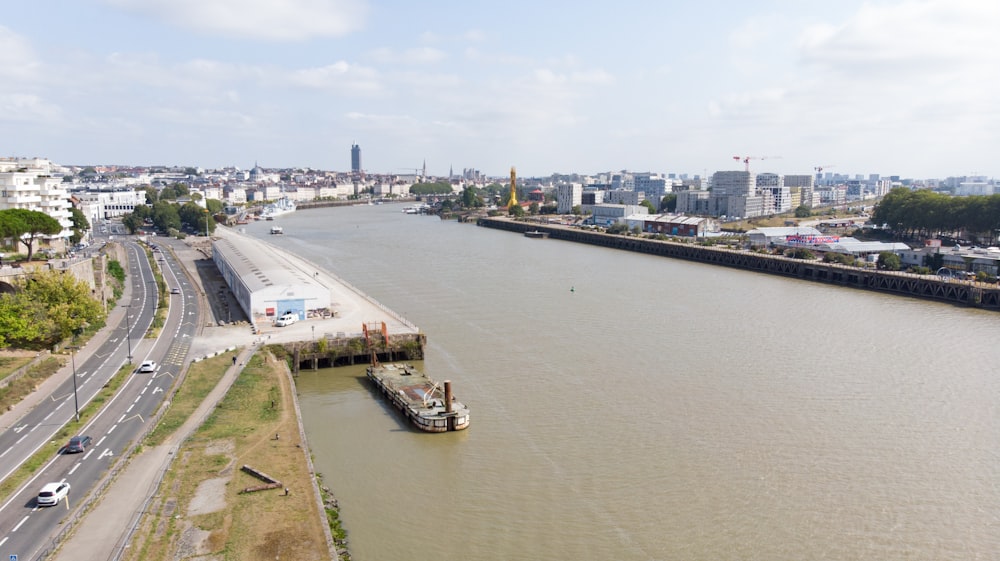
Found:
[0,239,198,560]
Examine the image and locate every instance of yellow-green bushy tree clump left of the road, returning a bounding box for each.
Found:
[0,271,105,350]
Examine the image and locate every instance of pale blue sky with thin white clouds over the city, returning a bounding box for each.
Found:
[0,0,1000,178]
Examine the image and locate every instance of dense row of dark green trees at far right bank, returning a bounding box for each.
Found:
[872,187,1000,243]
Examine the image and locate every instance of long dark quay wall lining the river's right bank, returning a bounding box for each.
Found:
[476,217,1000,311]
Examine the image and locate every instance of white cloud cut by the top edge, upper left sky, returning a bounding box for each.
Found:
[104,0,367,41]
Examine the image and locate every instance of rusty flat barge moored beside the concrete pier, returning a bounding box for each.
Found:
[367,362,469,432]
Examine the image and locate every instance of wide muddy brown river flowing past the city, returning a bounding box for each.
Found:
[247,205,1000,561]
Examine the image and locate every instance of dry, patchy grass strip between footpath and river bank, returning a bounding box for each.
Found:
[126,353,330,561]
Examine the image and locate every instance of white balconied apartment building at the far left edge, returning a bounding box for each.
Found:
[0,158,73,238]
